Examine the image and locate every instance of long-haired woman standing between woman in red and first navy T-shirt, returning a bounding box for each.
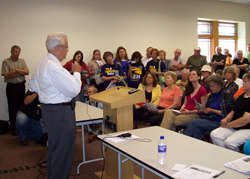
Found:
[88,49,106,92]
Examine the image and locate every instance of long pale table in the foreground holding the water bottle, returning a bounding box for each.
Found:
[98,126,249,179]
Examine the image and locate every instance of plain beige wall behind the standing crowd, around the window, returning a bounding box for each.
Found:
[0,0,250,120]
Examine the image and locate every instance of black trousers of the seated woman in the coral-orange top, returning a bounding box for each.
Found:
[143,106,165,126]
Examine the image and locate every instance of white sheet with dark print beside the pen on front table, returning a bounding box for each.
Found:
[172,165,221,179]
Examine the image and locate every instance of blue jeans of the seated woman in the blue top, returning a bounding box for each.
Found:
[184,118,220,139]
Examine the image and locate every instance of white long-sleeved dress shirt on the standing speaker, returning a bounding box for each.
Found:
[29,53,82,104]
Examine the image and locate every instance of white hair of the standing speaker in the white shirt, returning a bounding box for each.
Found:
[46,32,68,52]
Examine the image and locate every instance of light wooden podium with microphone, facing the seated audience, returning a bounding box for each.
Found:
[90,86,145,179]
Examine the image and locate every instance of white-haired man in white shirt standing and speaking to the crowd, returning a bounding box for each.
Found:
[30,32,81,179]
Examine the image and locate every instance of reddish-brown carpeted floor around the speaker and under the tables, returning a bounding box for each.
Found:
[0,124,158,179]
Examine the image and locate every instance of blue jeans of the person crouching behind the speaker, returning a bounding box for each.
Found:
[16,111,45,141]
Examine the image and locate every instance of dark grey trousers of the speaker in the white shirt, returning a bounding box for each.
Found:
[42,104,76,179]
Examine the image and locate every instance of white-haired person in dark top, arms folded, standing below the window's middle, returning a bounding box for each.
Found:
[211,46,227,71]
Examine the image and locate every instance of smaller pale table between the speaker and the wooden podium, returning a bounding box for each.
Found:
[75,101,104,175]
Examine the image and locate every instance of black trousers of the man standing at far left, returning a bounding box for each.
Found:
[6,82,25,131]
